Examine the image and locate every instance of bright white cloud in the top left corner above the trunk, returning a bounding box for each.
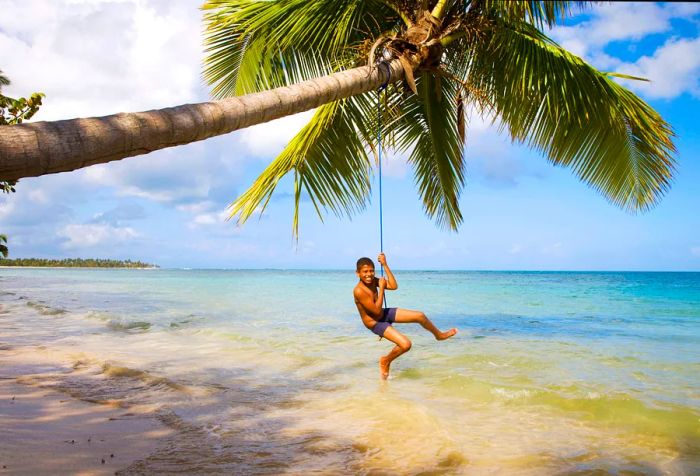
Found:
[0,0,202,120]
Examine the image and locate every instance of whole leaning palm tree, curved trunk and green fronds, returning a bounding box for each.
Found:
[0,0,675,235]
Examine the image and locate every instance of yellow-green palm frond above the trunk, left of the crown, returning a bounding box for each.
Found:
[203,0,401,98]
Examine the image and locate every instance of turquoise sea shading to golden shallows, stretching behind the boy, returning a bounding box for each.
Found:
[0,269,700,474]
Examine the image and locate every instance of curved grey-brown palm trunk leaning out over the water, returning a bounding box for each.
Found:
[0,60,404,180]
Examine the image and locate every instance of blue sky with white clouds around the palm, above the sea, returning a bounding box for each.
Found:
[0,0,700,271]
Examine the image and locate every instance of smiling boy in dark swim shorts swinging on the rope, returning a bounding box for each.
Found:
[353,253,457,379]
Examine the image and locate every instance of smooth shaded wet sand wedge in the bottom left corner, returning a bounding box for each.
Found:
[0,378,172,475]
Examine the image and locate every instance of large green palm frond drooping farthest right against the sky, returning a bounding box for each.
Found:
[469,23,675,211]
